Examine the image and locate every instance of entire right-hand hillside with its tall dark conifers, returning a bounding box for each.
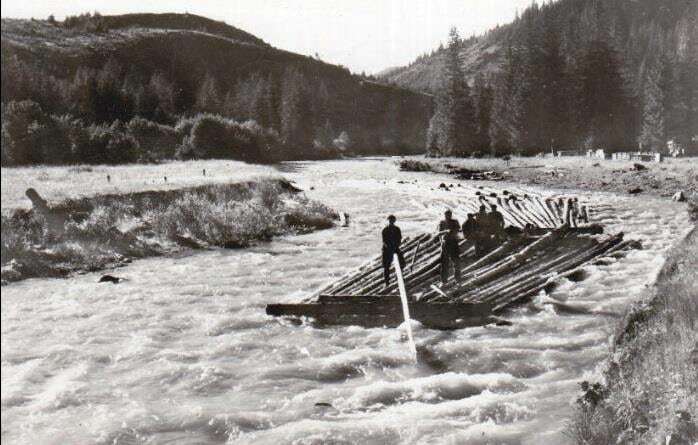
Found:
[381,0,698,155]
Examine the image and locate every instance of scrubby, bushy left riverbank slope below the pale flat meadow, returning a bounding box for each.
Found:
[2,178,337,283]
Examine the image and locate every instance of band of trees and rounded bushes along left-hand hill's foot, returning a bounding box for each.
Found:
[2,59,353,165]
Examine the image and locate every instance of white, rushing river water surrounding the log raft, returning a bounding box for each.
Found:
[2,159,688,445]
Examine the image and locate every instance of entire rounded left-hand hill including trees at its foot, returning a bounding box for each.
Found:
[2,14,432,165]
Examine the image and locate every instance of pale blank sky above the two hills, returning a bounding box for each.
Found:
[1,0,533,74]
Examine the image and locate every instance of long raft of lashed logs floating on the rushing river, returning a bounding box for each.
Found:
[266,192,632,329]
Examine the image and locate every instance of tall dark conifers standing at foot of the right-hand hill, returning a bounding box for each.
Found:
[427,1,698,156]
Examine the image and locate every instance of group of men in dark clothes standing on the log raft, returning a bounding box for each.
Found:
[382,205,507,287]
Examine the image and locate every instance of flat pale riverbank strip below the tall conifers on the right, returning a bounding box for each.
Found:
[396,157,698,197]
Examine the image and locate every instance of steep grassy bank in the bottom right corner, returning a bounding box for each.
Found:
[569,199,698,445]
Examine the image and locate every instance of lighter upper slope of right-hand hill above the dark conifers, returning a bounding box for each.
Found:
[377,0,698,93]
